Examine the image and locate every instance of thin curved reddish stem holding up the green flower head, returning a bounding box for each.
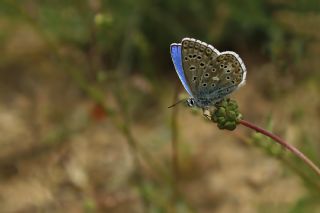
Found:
[239,120,320,176]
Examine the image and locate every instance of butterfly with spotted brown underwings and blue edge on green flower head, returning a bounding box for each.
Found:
[170,38,247,110]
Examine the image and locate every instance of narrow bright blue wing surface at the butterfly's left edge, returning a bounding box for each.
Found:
[170,43,193,97]
